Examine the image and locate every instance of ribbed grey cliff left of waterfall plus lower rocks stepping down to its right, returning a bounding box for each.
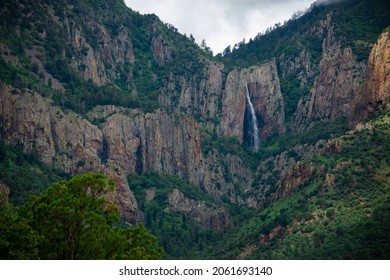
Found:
[101,107,252,207]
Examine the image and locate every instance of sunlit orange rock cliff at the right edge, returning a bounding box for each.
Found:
[350,30,390,123]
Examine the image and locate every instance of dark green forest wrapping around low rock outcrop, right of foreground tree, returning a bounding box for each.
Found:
[128,172,217,259]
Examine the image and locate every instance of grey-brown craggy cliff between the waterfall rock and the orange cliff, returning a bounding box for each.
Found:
[291,13,367,131]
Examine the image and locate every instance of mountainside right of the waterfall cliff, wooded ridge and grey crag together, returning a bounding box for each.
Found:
[222,1,390,132]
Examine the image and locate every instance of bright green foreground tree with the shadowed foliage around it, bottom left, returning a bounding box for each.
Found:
[0,173,163,259]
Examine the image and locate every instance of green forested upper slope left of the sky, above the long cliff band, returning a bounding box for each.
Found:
[0,0,210,114]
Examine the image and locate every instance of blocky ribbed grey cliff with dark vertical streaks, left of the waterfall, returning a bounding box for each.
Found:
[102,110,203,182]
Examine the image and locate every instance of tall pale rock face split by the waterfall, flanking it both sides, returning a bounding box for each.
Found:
[221,60,285,142]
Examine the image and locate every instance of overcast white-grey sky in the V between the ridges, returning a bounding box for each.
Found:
[125,0,314,54]
